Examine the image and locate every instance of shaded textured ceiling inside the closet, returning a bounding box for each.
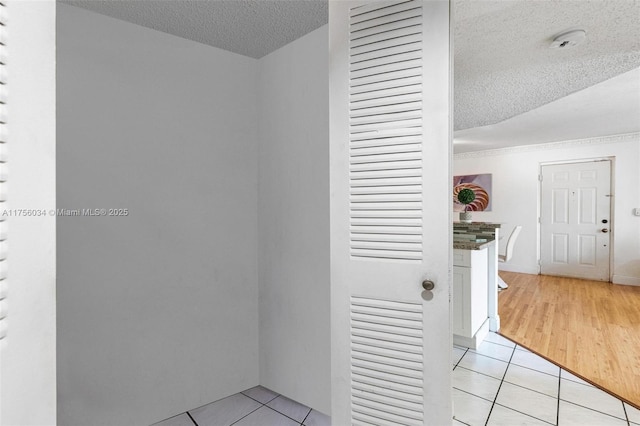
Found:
[59,0,328,58]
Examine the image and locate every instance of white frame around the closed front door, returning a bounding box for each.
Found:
[536,155,616,282]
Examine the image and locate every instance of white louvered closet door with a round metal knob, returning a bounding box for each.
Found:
[329,1,452,425]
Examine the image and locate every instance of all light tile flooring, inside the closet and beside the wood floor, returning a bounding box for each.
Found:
[154,333,640,426]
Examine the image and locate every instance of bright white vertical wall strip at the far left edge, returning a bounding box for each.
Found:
[0,0,56,426]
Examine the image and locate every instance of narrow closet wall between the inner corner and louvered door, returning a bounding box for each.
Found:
[258,26,331,414]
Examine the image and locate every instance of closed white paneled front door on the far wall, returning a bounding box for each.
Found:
[540,160,612,281]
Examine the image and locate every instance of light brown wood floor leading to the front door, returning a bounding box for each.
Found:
[498,271,640,409]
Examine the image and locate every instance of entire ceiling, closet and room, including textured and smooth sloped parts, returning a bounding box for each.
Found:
[59,0,640,152]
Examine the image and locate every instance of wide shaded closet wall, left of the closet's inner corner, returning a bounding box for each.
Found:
[57,5,259,426]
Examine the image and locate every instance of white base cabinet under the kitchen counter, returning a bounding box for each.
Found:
[453,249,488,347]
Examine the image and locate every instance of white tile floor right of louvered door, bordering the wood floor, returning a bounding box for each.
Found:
[452,333,640,426]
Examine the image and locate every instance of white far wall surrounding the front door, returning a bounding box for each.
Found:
[454,134,640,285]
